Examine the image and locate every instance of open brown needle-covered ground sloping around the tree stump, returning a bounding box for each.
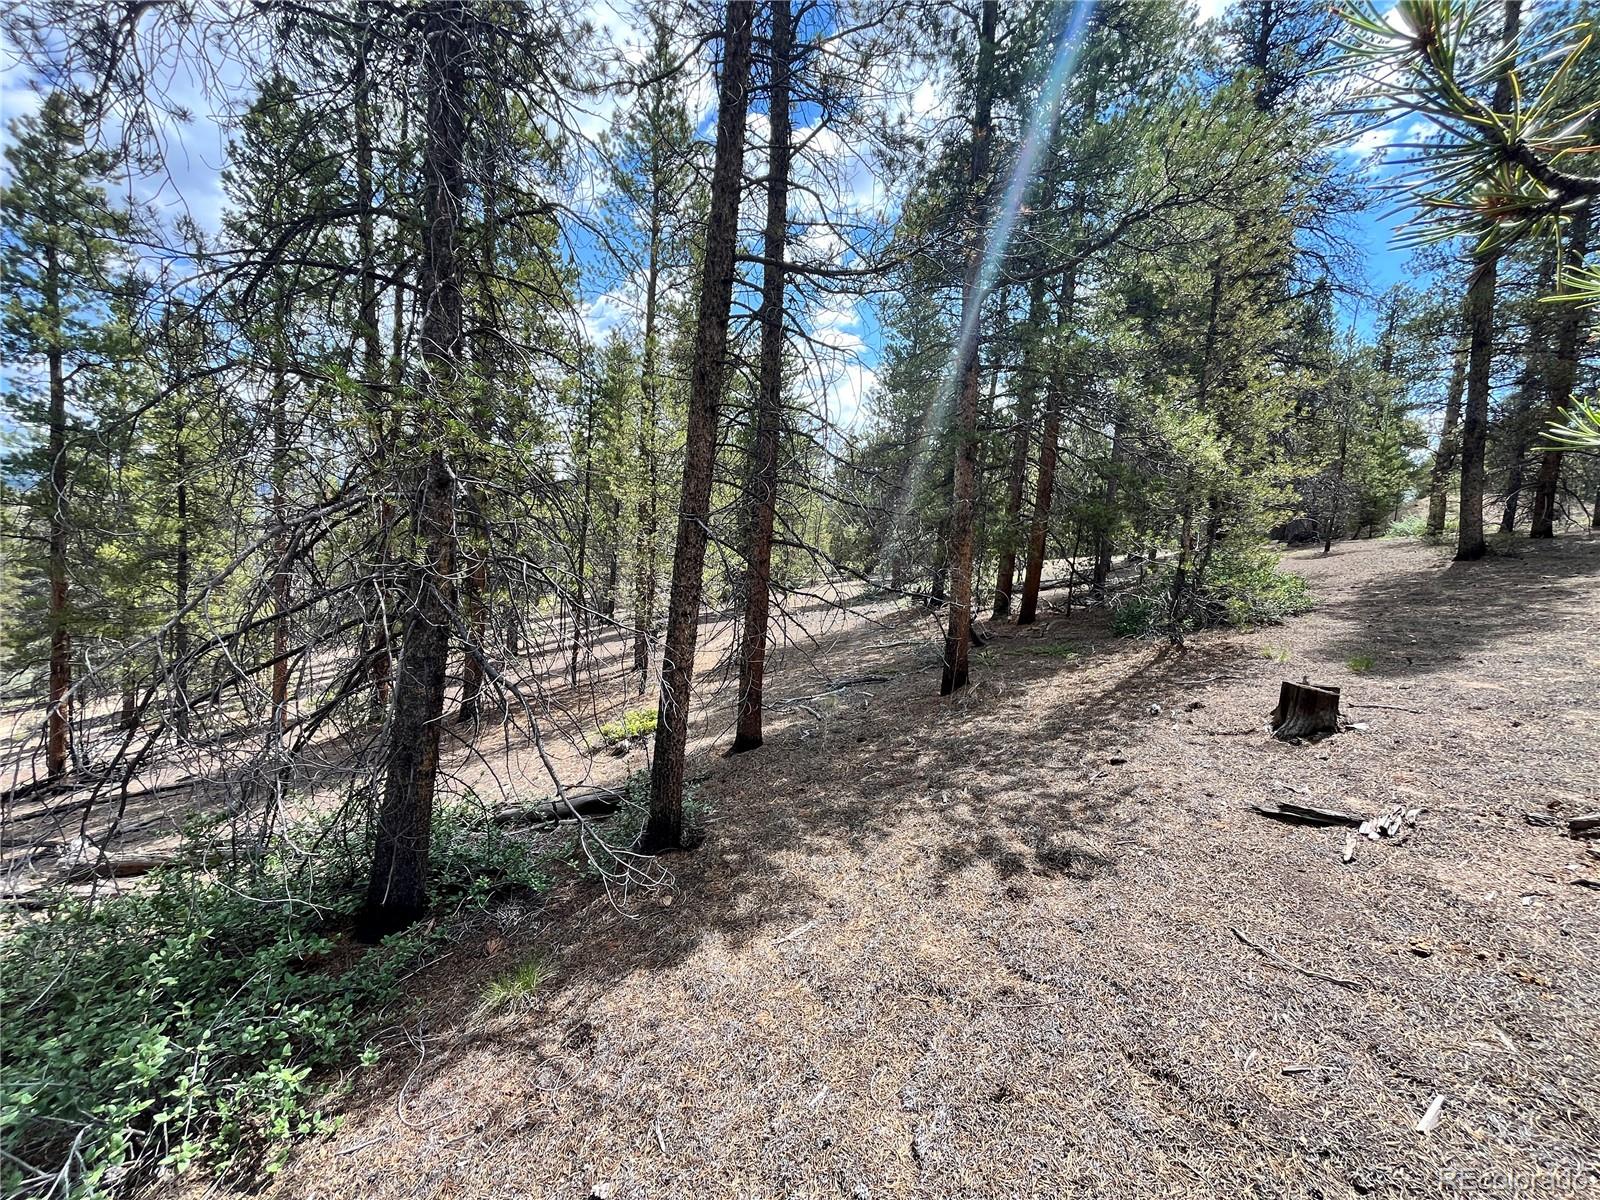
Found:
[181,536,1600,1200]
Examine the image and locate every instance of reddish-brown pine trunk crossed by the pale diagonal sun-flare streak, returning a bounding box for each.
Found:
[939,0,1000,696]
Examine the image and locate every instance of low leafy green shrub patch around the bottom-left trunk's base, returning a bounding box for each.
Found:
[0,805,546,1197]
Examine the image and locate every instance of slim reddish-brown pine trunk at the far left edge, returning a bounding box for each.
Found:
[43,245,72,779]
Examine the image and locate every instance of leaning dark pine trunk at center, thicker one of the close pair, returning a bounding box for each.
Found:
[637,0,755,854]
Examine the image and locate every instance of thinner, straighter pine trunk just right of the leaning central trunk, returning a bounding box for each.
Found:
[733,0,790,754]
